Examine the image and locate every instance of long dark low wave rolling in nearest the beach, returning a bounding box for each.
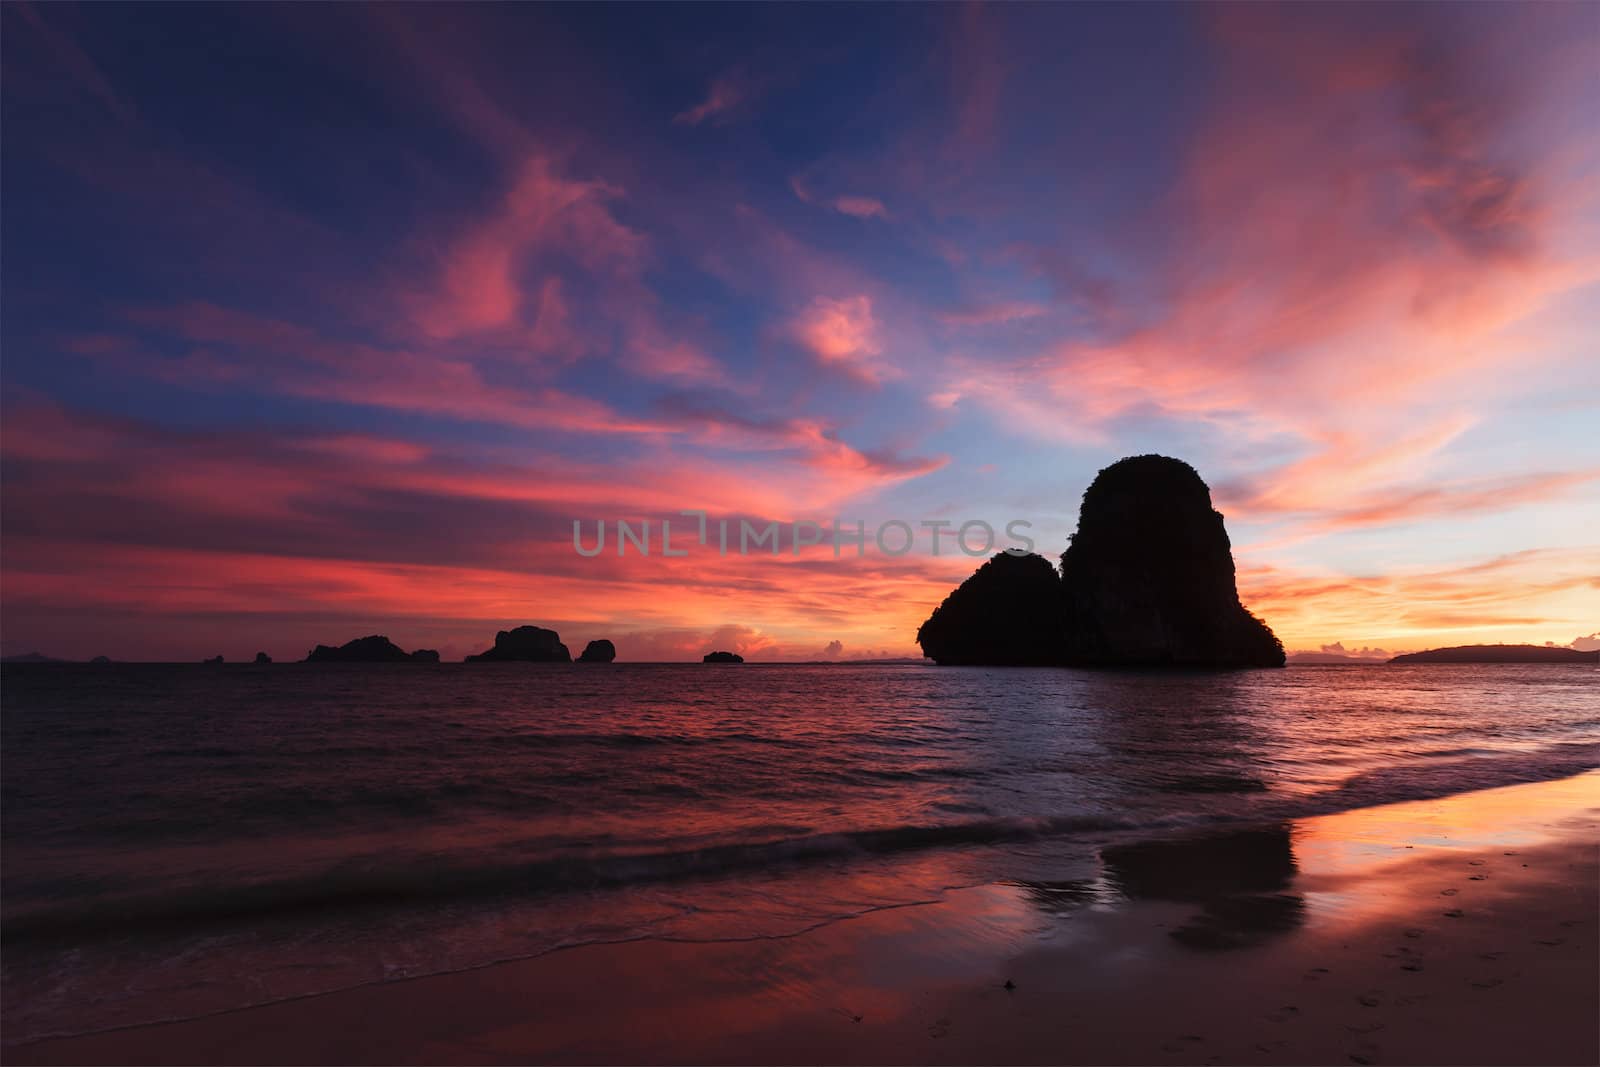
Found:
[0,742,1600,942]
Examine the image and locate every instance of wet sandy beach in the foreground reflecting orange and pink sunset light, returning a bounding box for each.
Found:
[15,771,1600,1064]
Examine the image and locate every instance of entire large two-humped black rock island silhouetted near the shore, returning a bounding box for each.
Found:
[917,456,1285,667]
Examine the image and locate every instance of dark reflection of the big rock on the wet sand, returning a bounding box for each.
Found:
[1021,825,1306,950]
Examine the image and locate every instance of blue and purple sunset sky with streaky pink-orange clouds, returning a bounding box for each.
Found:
[0,3,1600,661]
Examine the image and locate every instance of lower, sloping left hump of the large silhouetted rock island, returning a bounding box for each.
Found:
[917,552,1062,667]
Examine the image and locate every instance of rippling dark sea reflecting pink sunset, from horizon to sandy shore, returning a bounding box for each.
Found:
[0,664,1600,1045]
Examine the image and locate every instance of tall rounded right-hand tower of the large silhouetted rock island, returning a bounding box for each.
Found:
[1061,456,1283,667]
